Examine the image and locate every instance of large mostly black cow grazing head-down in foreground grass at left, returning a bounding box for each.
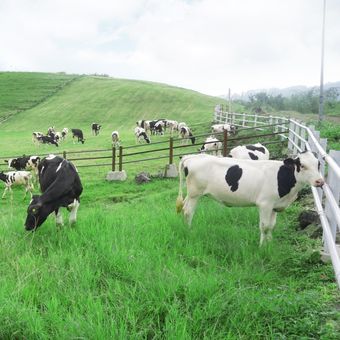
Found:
[25,155,83,230]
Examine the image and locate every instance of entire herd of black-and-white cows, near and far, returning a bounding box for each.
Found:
[0,119,324,244]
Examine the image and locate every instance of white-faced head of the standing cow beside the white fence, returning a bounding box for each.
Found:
[284,151,325,187]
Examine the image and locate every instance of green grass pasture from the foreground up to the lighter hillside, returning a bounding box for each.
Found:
[0,73,340,339]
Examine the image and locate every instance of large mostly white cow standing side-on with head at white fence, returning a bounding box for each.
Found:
[176,152,324,244]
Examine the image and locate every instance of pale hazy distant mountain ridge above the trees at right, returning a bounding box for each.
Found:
[221,81,340,101]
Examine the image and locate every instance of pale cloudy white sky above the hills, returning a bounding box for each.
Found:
[0,0,340,95]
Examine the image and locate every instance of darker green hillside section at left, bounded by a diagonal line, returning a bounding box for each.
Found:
[0,72,79,121]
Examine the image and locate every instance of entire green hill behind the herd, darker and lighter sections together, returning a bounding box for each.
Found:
[0,72,231,131]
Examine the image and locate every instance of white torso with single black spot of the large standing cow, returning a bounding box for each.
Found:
[183,155,282,206]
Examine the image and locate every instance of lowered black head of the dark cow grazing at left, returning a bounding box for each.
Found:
[25,195,53,231]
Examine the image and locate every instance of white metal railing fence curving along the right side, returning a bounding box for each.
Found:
[214,105,340,287]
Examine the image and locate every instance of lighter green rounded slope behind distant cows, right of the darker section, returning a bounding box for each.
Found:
[2,76,228,131]
